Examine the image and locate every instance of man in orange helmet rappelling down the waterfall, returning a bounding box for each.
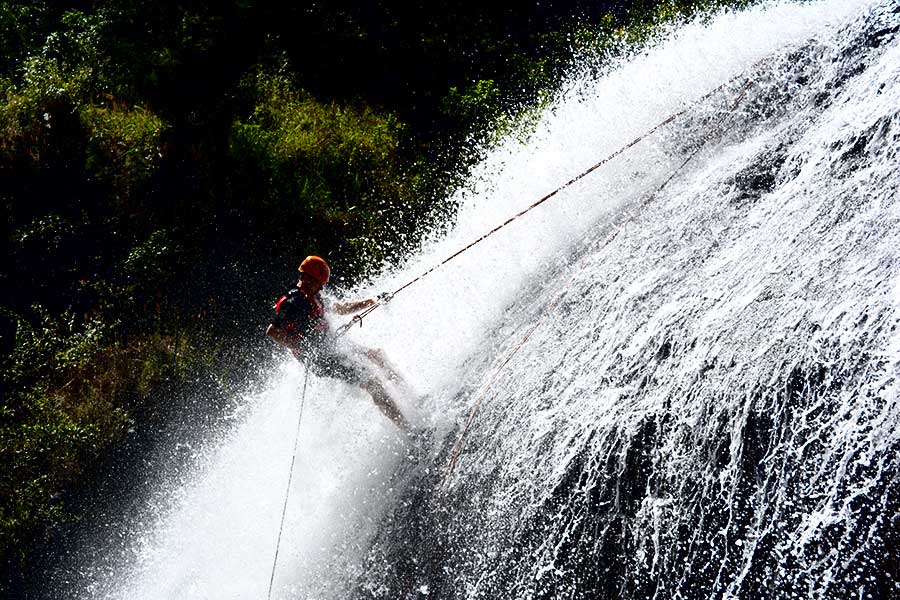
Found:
[266,256,410,431]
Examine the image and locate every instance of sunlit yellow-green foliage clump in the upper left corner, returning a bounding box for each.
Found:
[0,6,165,190]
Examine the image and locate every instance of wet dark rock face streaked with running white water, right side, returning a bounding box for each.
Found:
[361,2,900,600]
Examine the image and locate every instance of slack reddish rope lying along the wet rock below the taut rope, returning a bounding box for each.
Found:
[440,78,752,490]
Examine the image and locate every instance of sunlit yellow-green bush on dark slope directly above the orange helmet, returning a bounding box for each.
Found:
[230,71,421,274]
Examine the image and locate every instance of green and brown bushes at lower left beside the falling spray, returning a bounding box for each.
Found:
[0,302,215,558]
